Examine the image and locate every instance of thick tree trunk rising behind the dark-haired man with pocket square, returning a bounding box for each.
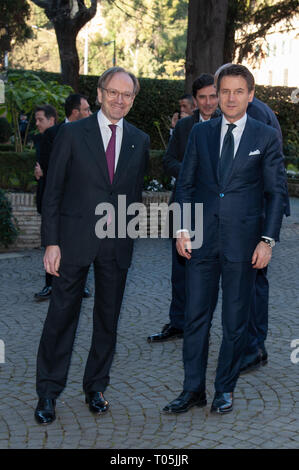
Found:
[185,0,228,93]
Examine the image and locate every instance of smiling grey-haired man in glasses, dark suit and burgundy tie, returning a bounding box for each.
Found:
[35,67,149,424]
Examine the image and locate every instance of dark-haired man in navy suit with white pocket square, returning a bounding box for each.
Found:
[163,65,285,413]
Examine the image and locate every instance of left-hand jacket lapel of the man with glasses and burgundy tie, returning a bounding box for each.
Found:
[84,113,111,184]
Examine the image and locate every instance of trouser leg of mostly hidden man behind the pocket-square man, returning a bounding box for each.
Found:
[246,267,269,354]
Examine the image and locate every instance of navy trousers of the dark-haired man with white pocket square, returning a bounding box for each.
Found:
[183,256,255,392]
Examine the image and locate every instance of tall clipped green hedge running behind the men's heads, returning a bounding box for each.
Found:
[7,72,299,156]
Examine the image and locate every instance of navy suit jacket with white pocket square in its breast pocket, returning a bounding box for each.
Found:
[176,116,285,262]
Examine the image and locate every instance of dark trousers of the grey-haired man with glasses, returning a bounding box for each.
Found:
[36,239,127,398]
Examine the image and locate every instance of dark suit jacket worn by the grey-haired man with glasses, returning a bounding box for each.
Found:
[42,113,149,269]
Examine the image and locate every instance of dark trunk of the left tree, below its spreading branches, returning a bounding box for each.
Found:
[55,24,80,92]
